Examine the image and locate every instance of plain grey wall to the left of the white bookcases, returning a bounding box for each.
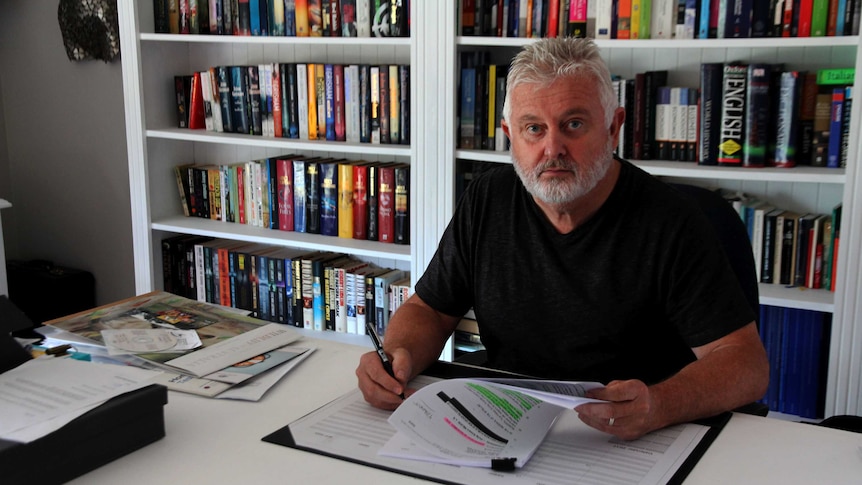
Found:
[0,0,135,304]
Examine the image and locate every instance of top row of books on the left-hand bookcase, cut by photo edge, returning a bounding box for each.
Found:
[153,0,410,37]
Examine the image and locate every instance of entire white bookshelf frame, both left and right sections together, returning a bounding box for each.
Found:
[118,0,862,415]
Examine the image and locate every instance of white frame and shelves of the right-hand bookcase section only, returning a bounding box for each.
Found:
[440,2,862,416]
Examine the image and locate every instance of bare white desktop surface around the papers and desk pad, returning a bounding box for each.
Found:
[71,332,862,485]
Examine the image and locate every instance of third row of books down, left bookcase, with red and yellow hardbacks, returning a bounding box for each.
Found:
[174,155,410,244]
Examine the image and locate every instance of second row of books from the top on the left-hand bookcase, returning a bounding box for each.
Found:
[174,63,410,145]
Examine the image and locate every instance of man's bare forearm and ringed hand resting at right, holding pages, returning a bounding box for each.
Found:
[576,322,769,439]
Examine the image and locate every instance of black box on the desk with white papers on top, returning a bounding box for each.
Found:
[0,382,168,485]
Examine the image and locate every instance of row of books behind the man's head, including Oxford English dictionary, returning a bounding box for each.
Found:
[458,52,855,168]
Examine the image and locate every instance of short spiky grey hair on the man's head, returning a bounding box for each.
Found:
[503,37,619,124]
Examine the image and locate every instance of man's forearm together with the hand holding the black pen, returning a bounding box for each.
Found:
[356,294,460,409]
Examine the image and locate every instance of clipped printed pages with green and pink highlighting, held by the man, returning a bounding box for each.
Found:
[379,378,604,469]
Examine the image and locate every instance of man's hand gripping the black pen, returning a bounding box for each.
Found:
[356,348,414,410]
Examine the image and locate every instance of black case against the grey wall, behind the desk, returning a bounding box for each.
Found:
[6,260,96,325]
